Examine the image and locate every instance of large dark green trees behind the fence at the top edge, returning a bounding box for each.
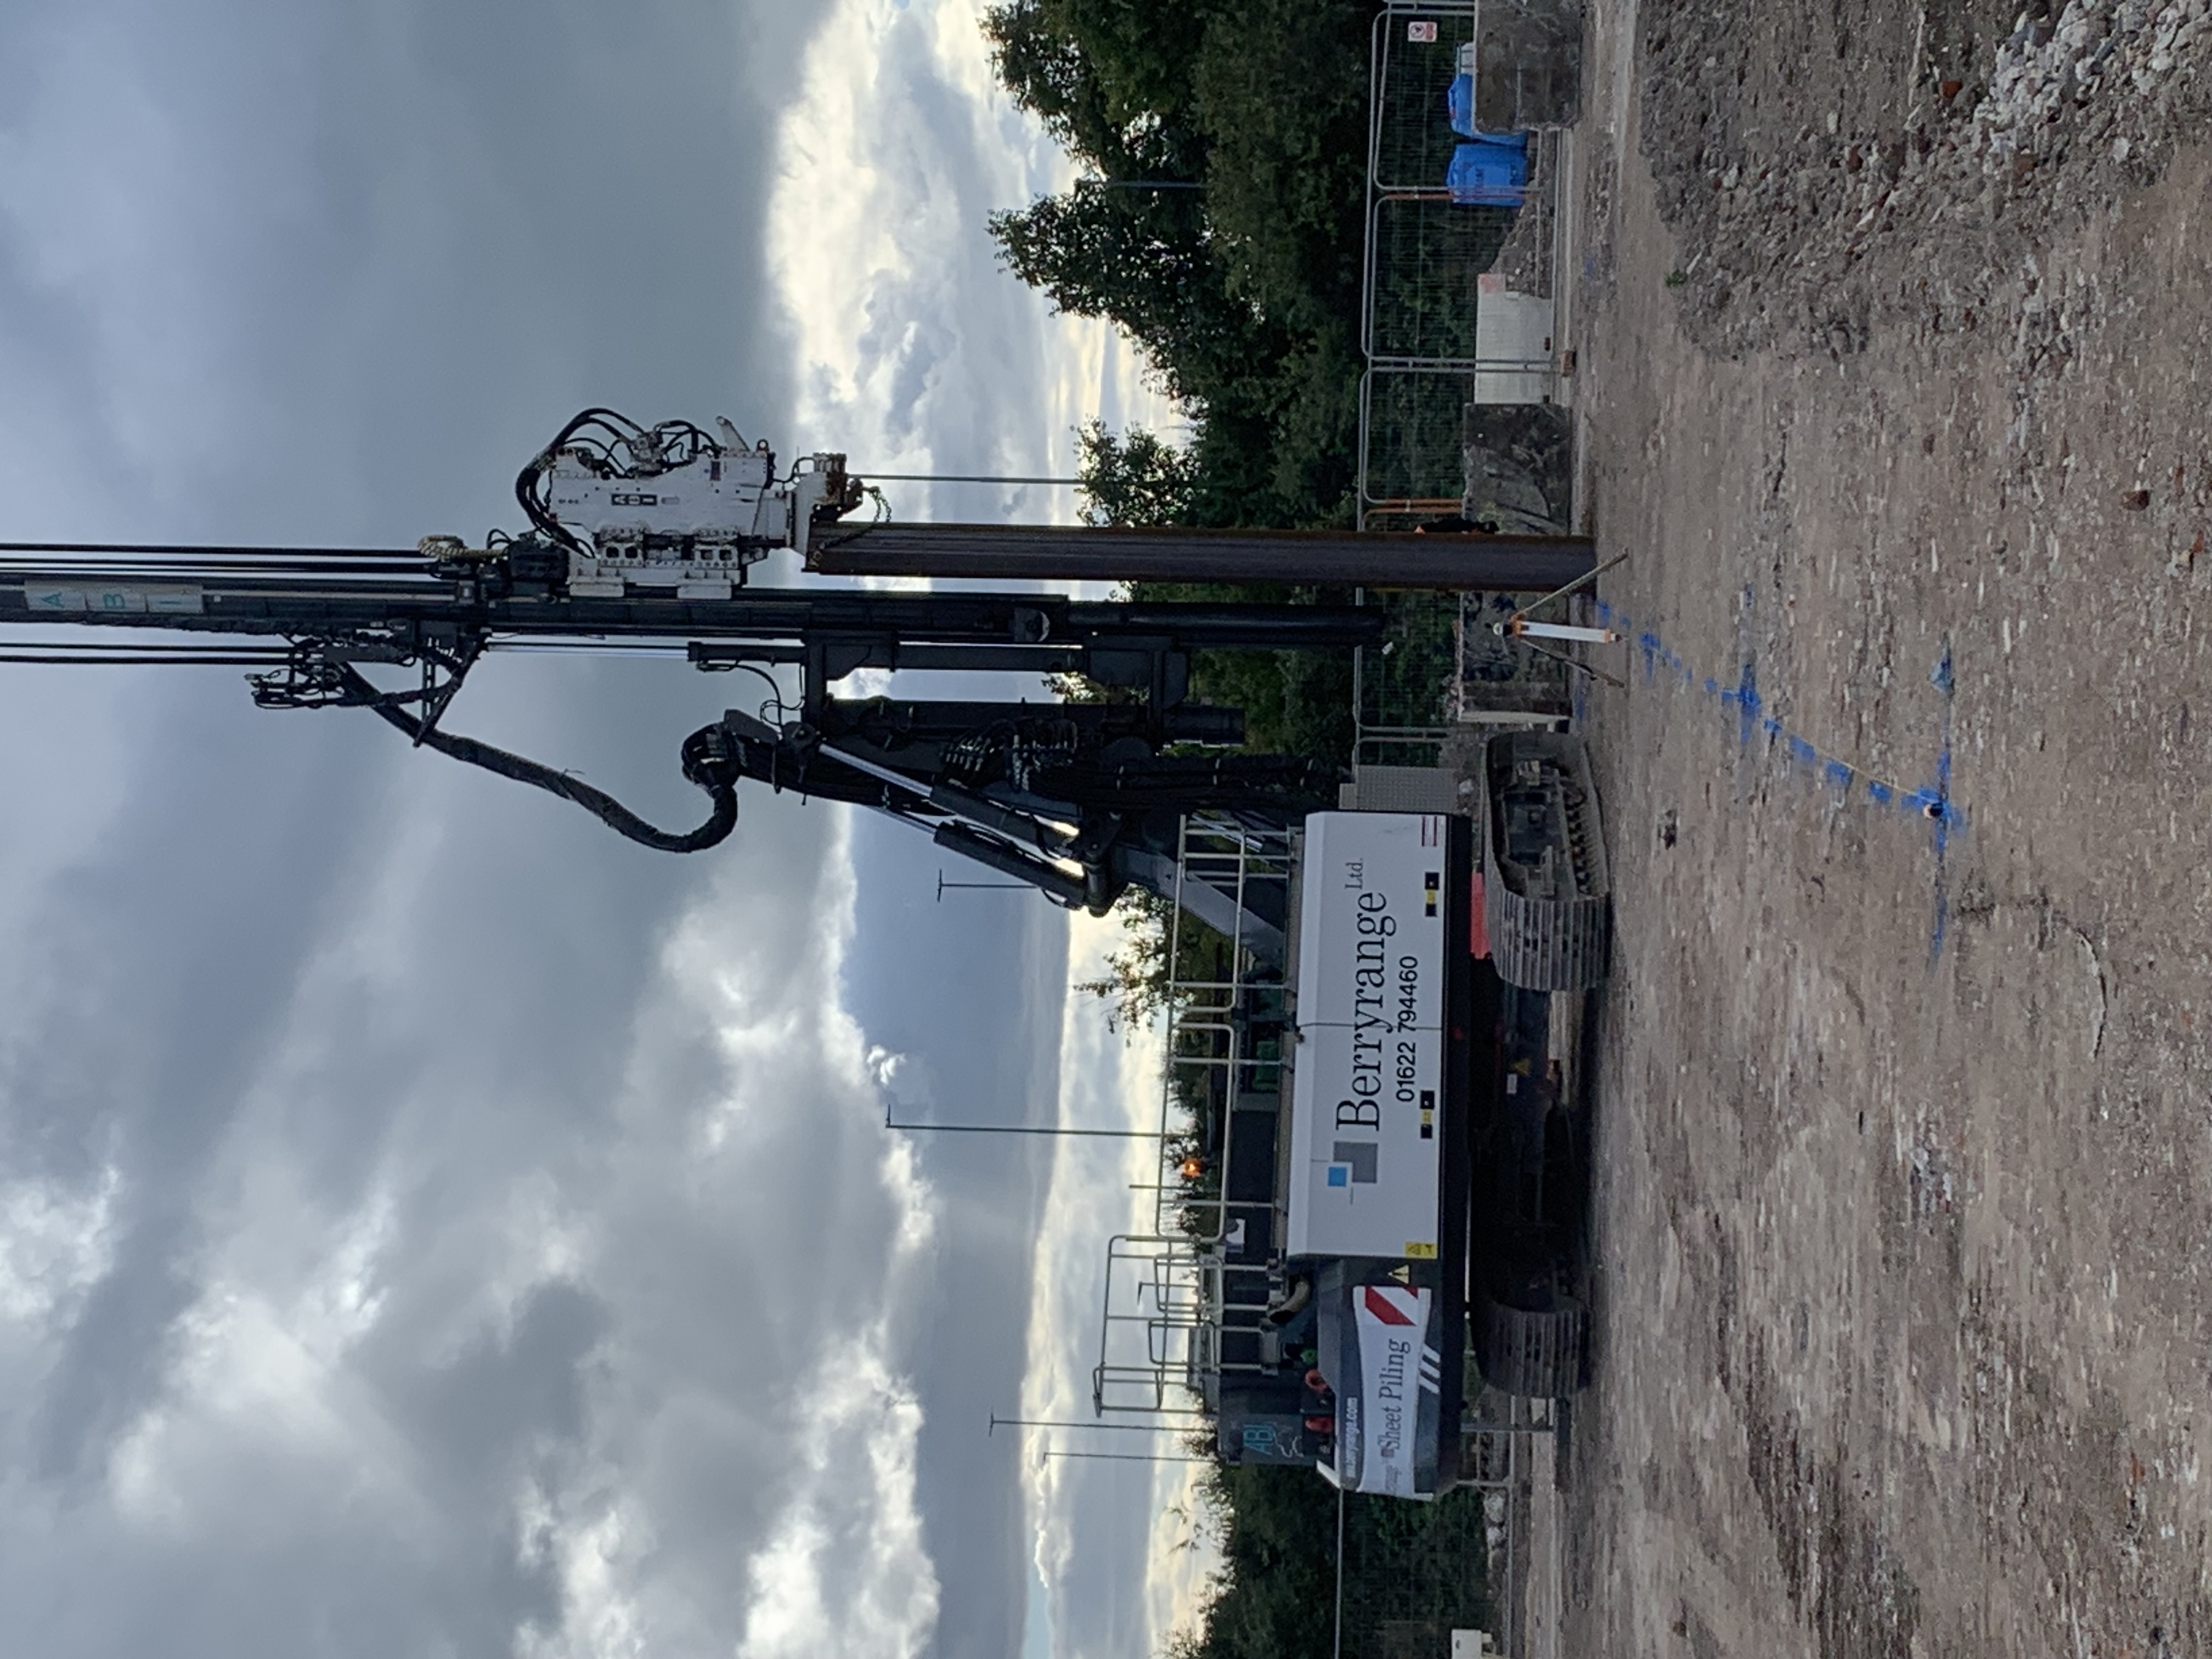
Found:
[984,0,1372,527]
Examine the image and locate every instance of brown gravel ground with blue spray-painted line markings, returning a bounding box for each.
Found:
[1564,0,2212,1659]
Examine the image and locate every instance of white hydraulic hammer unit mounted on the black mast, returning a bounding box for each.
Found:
[542,420,845,600]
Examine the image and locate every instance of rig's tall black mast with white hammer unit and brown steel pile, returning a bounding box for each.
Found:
[0,409,1590,911]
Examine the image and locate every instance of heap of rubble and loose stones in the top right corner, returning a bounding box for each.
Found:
[1637,0,2212,356]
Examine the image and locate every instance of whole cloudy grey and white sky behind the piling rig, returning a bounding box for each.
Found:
[0,0,1203,1659]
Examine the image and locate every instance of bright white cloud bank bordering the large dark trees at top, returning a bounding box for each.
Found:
[770,0,1170,520]
